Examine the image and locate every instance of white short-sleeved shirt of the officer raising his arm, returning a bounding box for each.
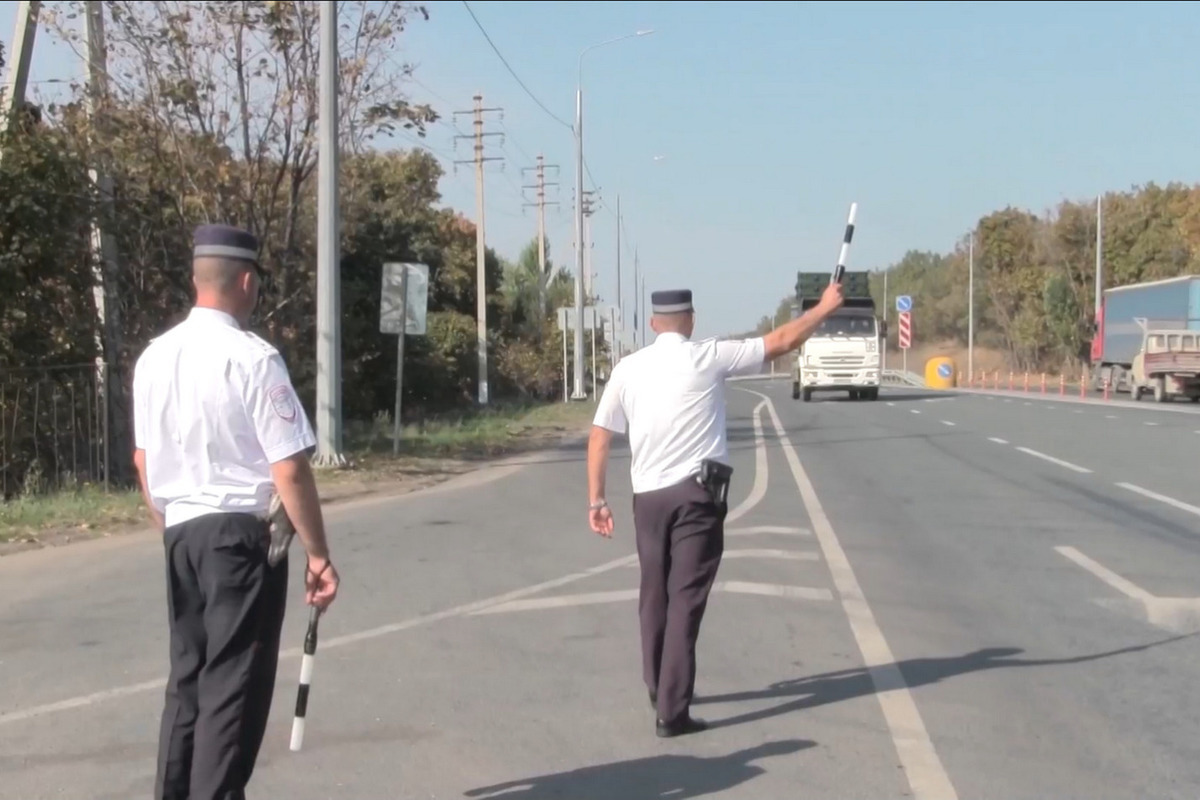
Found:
[593,333,766,493]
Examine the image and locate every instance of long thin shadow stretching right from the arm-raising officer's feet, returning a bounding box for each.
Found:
[692,633,1195,729]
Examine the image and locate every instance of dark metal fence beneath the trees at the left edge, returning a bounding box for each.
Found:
[0,363,110,500]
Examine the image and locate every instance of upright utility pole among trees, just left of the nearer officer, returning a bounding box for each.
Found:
[84,0,126,486]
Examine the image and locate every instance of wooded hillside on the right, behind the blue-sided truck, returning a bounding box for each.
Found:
[756,184,1200,375]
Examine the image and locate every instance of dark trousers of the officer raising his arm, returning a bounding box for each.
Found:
[634,477,726,722]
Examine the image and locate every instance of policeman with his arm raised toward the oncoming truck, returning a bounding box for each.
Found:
[588,283,842,736]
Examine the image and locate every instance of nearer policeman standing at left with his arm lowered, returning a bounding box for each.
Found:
[133,225,338,800]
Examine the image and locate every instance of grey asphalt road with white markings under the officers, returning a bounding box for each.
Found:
[0,381,1200,800]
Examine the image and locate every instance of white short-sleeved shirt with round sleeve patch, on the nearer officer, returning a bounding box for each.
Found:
[133,308,317,527]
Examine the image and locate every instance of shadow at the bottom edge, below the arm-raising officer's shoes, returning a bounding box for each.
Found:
[463,739,816,800]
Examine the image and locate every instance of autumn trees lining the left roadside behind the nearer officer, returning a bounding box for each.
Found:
[0,0,602,497]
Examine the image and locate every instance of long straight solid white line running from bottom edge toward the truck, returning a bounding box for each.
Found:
[743,390,958,800]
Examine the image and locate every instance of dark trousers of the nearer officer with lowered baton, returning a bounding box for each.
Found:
[155,513,288,800]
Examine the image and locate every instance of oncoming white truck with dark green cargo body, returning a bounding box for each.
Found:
[792,272,887,402]
